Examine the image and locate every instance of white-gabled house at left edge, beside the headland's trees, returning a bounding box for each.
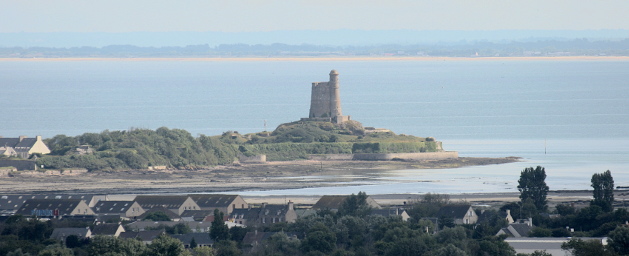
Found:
[0,136,50,158]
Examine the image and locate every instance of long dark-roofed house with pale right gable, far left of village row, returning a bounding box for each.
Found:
[15,199,95,217]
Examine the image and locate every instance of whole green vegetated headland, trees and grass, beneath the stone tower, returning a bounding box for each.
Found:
[37,121,437,171]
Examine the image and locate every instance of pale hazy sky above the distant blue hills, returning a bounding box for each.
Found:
[0,0,629,32]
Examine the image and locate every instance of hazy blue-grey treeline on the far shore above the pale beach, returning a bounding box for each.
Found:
[0,38,629,58]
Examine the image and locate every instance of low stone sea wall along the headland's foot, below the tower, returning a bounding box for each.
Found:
[308,151,459,161]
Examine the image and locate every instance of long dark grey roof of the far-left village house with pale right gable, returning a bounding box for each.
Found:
[16,199,81,216]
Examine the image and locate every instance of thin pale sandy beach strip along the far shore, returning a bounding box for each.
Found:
[0,56,629,62]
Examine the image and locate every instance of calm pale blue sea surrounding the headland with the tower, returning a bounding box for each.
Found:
[0,58,629,195]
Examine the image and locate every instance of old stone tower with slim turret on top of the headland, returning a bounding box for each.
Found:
[308,70,350,123]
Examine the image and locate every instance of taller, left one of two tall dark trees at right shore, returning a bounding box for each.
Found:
[518,166,548,211]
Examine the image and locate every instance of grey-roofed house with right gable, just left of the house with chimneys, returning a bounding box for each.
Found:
[188,194,249,215]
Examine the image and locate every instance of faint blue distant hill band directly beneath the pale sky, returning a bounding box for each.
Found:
[0,30,629,48]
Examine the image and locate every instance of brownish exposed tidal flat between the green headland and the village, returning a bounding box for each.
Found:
[0,157,519,194]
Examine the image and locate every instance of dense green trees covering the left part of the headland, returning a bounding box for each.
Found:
[37,127,237,171]
